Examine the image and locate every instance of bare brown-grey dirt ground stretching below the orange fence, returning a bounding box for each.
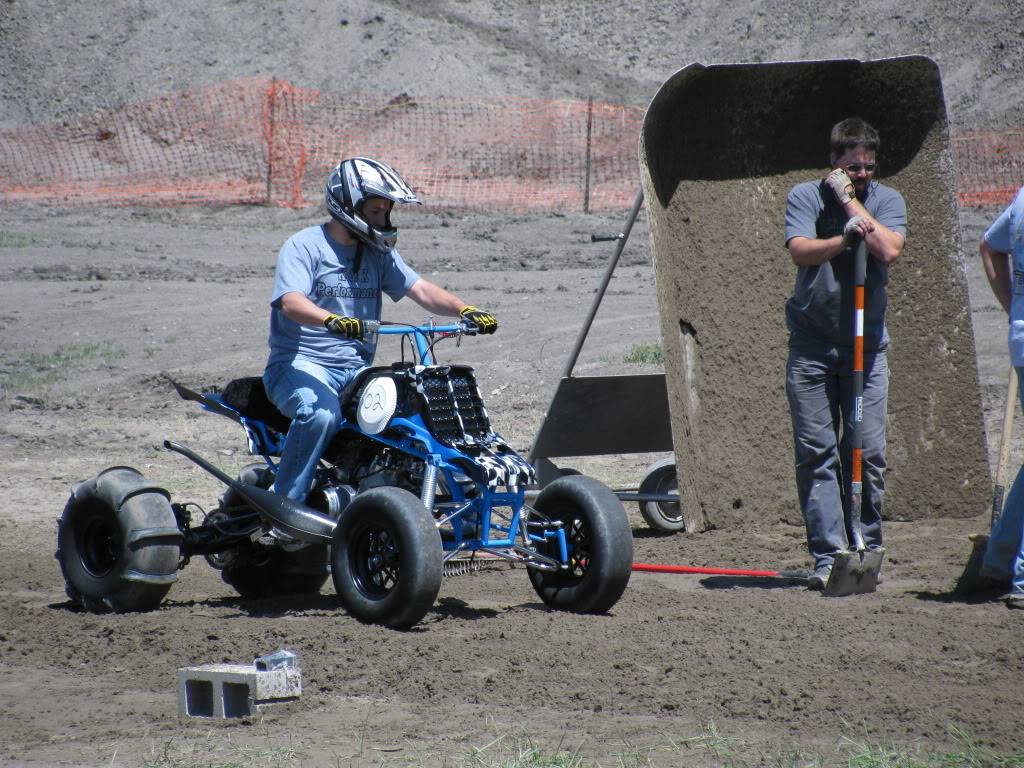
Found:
[0,199,1024,766]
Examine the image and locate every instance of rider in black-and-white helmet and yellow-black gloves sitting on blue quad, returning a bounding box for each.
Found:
[263,158,498,502]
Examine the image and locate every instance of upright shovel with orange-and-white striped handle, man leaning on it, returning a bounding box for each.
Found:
[823,238,885,597]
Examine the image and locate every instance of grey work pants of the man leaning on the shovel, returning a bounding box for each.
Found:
[785,345,889,568]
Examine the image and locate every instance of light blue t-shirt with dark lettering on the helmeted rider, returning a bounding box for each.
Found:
[267,225,420,369]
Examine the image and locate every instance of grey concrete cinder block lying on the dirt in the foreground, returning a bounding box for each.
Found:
[178,664,302,718]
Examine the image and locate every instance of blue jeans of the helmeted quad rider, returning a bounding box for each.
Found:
[263,358,362,502]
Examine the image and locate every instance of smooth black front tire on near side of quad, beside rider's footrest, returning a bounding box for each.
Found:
[331,486,442,629]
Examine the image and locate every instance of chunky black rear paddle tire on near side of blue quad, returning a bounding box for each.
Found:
[56,467,182,613]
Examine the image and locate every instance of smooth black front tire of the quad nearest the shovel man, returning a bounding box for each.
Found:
[529,475,633,613]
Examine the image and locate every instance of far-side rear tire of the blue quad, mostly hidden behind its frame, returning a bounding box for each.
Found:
[215,463,330,599]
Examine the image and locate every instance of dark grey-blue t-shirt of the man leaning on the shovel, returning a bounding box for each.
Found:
[785,180,906,351]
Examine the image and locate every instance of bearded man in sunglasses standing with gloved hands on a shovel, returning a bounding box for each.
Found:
[785,118,906,590]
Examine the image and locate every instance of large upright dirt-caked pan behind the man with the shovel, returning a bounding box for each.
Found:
[640,56,991,529]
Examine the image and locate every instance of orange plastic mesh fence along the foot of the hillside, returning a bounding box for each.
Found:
[0,78,1024,211]
